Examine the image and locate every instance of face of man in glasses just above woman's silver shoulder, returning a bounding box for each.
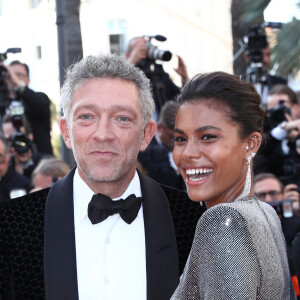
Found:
[254,178,283,202]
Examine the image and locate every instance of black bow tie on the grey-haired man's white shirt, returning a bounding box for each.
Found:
[88,194,142,224]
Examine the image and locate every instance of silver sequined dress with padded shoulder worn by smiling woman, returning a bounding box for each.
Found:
[171,197,296,300]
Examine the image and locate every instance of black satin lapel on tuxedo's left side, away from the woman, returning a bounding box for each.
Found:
[44,168,78,300]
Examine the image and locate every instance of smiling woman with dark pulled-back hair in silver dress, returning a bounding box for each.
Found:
[172,72,296,300]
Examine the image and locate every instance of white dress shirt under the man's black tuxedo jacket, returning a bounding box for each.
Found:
[73,170,147,300]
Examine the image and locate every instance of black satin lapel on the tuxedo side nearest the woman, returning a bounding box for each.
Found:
[138,172,179,300]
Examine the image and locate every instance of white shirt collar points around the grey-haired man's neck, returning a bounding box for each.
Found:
[73,168,142,226]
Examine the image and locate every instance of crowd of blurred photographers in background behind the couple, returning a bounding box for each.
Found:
[0,37,300,296]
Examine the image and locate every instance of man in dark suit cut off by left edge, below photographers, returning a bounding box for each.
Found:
[0,134,30,202]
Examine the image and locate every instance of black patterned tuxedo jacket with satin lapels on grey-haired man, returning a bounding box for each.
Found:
[0,170,203,300]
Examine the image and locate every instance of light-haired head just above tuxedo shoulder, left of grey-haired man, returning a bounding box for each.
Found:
[30,158,70,193]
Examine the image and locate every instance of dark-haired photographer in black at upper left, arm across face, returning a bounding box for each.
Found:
[1,61,53,154]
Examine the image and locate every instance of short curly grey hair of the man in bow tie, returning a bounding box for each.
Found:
[61,54,155,127]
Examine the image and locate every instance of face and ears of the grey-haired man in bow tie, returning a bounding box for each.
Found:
[61,78,155,193]
